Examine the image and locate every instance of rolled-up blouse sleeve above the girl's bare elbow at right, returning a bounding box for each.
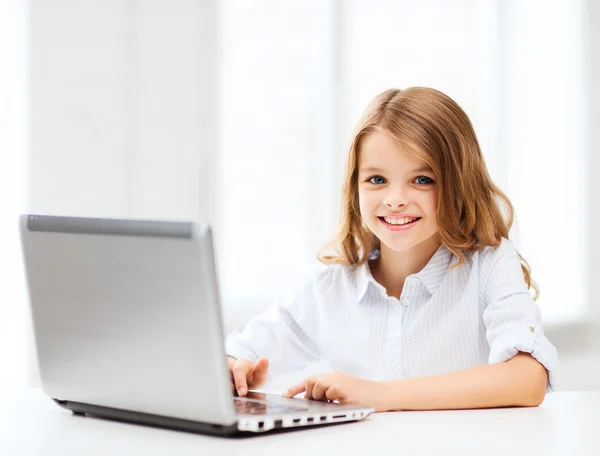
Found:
[483,239,557,391]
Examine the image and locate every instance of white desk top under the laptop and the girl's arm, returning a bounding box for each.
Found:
[0,388,600,456]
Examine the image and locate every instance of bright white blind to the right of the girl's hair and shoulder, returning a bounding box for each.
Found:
[498,0,591,324]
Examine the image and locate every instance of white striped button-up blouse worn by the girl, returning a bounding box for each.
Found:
[226,239,557,390]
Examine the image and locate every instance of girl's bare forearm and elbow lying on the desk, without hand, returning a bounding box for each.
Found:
[386,352,548,410]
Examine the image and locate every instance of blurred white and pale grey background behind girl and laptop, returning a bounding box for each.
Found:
[0,0,600,389]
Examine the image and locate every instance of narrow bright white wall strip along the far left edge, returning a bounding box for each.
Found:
[0,0,31,384]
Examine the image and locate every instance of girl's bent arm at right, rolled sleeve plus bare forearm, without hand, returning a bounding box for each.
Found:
[386,239,557,410]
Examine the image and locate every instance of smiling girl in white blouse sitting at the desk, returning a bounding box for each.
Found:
[226,87,557,411]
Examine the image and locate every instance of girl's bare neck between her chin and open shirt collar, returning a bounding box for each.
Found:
[370,233,441,298]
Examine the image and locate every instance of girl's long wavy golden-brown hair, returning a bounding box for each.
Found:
[318,87,539,300]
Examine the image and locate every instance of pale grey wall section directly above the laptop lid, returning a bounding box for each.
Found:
[22,0,217,383]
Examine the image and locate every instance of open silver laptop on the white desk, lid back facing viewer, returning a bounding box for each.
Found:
[20,214,374,435]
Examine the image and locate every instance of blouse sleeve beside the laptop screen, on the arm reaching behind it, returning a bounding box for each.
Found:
[225,269,327,373]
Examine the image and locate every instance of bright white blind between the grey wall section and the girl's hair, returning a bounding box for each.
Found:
[215,0,337,306]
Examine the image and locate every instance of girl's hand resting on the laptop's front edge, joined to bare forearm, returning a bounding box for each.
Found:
[284,371,391,412]
